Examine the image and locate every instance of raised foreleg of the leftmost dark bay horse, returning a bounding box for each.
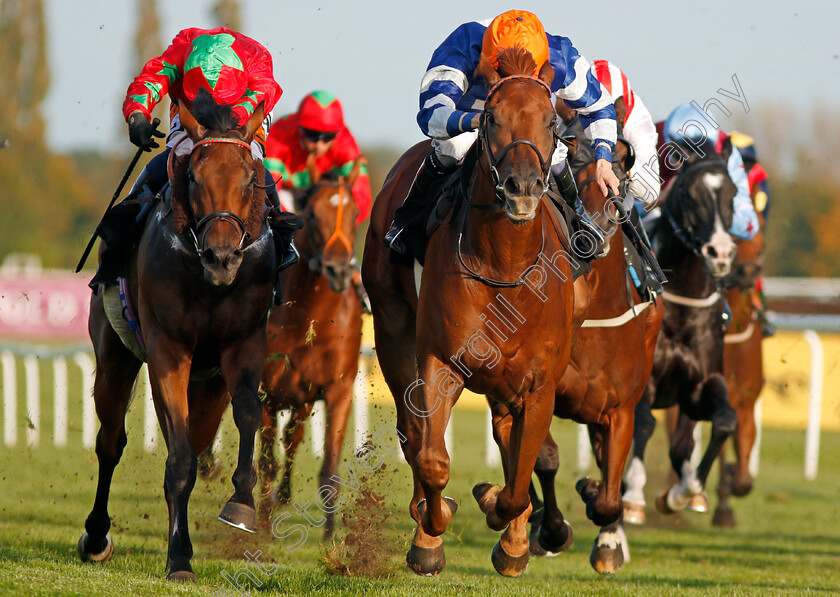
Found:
[219,328,266,533]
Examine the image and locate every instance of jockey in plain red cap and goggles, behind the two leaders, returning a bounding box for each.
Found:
[265,91,371,313]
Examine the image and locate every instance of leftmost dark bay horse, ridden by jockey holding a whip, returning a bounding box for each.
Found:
[77,94,275,580]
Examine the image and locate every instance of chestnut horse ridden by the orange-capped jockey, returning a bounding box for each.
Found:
[362,48,574,576]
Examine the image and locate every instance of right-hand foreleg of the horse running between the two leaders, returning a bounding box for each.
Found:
[318,379,353,539]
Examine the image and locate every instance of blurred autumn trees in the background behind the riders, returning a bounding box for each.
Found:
[0,0,840,276]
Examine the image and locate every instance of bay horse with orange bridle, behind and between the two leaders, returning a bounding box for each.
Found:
[259,161,362,538]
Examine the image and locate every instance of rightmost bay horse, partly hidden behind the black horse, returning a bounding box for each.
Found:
[712,206,764,527]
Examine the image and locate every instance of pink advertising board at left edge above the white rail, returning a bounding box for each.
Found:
[0,270,90,341]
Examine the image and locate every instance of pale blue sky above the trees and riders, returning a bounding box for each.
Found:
[43,0,840,150]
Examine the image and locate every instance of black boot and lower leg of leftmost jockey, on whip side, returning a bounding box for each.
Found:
[88,163,166,290]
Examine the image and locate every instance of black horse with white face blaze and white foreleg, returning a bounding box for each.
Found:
[624,154,737,522]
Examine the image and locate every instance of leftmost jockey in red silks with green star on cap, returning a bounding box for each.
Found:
[90,27,298,288]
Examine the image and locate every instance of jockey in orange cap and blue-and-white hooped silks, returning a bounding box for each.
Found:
[385,10,619,260]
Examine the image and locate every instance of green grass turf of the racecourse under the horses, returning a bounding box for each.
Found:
[0,375,840,595]
